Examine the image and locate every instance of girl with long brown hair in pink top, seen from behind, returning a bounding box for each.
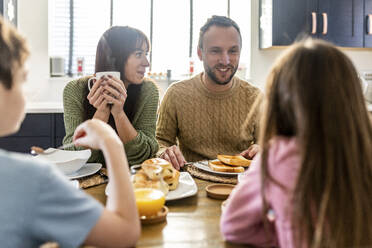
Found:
[221,40,372,248]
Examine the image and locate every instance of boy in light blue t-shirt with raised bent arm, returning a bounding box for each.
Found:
[0,18,140,247]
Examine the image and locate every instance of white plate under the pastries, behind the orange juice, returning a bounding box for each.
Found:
[105,172,198,201]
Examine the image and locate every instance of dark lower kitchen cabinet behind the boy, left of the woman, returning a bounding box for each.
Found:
[0,113,65,153]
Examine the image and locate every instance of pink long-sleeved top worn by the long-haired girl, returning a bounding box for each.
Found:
[220,137,300,248]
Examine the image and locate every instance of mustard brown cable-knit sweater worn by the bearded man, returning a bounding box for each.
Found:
[156,74,262,162]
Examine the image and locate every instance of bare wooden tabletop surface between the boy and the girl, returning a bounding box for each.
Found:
[85,178,251,248]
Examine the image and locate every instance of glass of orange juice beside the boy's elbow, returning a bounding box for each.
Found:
[134,188,165,216]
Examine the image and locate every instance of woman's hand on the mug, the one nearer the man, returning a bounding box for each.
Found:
[103,77,127,117]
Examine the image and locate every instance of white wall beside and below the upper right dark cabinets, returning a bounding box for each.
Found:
[250,0,372,89]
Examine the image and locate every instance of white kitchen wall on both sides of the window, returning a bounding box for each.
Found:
[14,0,372,101]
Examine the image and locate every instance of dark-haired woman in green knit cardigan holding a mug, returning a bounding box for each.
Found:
[63,26,159,165]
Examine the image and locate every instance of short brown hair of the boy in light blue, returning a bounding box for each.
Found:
[0,17,29,89]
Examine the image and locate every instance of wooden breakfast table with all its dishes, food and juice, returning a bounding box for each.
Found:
[35,148,251,248]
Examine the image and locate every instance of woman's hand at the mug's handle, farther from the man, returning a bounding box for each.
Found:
[87,77,110,113]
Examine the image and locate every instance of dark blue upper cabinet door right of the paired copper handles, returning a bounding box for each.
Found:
[318,0,364,47]
